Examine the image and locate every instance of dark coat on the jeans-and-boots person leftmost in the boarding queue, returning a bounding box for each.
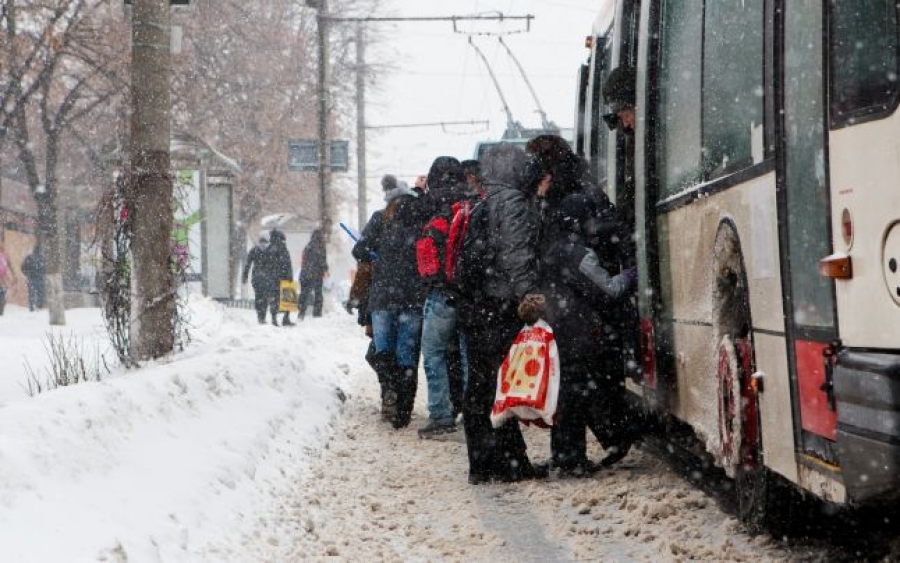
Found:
[353,195,425,313]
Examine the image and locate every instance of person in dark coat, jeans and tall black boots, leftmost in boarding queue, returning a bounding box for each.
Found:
[353,175,425,429]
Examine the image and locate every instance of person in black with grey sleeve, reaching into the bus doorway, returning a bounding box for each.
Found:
[541,194,635,477]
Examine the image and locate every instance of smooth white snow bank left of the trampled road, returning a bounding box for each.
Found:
[0,301,363,561]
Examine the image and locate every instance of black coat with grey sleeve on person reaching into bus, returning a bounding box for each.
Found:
[541,233,631,362]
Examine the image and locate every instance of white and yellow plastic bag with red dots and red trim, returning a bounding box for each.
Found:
[491,320,559,428]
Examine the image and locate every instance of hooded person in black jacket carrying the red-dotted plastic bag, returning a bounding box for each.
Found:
[458,143,546,484]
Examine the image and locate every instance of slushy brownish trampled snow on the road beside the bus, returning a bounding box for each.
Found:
[232,328,826,561]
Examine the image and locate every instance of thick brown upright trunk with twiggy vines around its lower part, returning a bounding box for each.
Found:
[128,0,176,360]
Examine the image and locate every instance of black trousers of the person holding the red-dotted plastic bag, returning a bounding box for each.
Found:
[461,303,531,480]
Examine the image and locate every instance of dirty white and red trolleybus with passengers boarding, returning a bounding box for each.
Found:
[575,0,900,519]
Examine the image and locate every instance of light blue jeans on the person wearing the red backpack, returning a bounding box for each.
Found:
[422,289,468,421]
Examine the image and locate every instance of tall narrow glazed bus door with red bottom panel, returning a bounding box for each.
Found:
[778,0,838,463]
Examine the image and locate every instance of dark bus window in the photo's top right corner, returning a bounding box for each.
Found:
[831,0,900,125]
